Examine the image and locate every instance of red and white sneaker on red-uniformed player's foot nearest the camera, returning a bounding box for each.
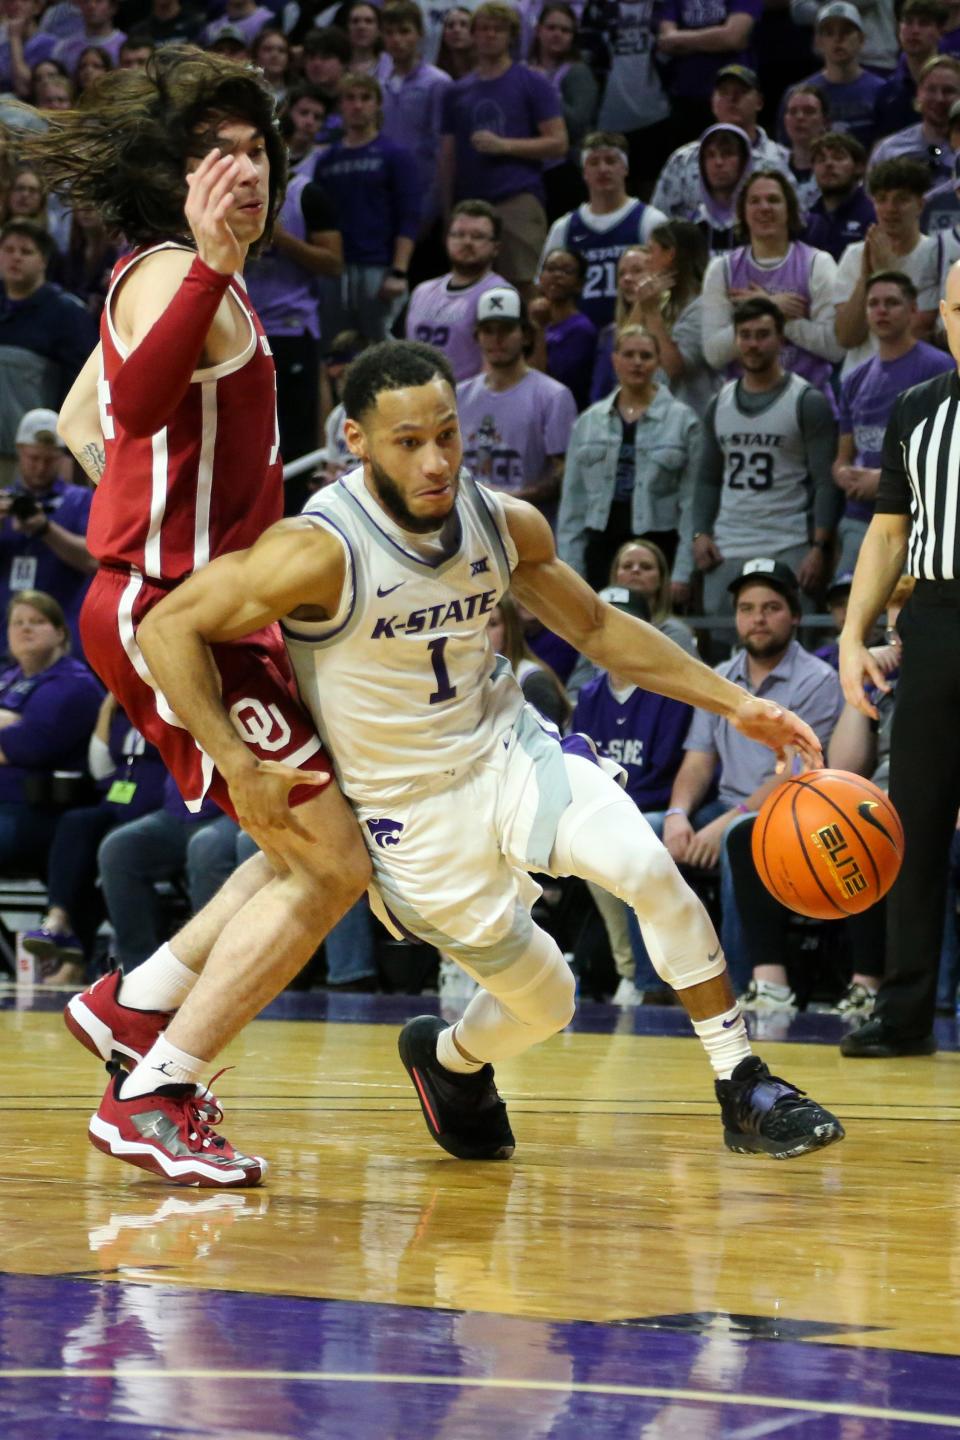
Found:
[89,1073,268,1189]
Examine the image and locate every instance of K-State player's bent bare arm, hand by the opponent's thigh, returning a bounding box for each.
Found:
[137,520,344,850]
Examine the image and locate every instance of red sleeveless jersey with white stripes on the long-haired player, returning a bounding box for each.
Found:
[86,242,284,582]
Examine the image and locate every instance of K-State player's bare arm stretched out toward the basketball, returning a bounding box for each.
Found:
[504,497,823,766]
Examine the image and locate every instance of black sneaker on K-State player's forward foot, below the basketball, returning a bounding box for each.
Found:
[715,1056,843,1161]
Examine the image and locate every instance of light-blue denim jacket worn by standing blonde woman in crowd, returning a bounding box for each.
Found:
[557,384,702,582]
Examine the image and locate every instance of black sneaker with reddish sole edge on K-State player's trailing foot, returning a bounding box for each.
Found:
[397,1015,515,1161]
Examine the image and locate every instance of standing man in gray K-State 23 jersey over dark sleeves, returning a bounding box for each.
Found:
[692,297,841,615]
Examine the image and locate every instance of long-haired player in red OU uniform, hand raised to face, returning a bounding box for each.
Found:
[19,46,368,1187]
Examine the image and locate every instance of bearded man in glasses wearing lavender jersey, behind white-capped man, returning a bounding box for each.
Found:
[404,200,507,380]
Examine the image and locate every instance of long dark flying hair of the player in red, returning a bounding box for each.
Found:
[13,45,286,245]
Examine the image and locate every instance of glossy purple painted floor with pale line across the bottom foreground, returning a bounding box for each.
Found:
[0,1274,960,1440]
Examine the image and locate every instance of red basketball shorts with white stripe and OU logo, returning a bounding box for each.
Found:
[81,569,332,818]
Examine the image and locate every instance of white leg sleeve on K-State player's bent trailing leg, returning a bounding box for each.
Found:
[456,929,576,1061]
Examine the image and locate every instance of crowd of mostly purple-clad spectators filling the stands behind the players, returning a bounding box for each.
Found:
[0,0,960,1014]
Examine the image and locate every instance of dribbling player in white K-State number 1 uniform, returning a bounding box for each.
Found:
[138,341,843,1159]
